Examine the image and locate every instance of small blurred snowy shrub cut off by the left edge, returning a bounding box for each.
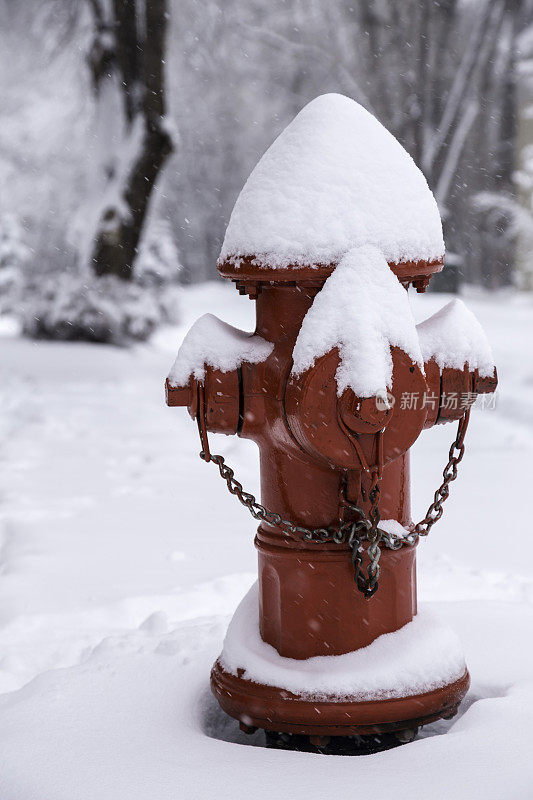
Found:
[0,214,30,314]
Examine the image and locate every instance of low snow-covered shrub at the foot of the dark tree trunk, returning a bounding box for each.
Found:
[22,274,161,344]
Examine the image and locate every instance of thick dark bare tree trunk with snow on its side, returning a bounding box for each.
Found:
[85,0,173,280]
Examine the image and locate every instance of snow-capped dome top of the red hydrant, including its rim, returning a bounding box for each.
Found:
[218,94,444,280]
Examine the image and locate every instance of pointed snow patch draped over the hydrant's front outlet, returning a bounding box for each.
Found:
[292,245,423,397]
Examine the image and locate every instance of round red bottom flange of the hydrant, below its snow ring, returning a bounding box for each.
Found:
[211,661,470,736]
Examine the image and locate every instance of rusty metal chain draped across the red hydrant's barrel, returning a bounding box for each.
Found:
[196,383,470,599]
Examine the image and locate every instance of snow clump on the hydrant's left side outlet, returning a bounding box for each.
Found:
[168,314,274,386]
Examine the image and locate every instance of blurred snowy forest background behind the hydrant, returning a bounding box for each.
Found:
[0,0,533,341]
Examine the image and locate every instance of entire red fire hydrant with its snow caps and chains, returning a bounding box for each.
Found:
[166,95,497,752]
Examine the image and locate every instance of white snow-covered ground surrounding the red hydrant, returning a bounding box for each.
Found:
[0,283,533,800]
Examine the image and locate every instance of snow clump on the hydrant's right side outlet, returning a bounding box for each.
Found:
[416,299,495,378]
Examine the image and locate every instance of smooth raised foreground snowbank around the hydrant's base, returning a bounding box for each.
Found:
[0,601,533,800]
